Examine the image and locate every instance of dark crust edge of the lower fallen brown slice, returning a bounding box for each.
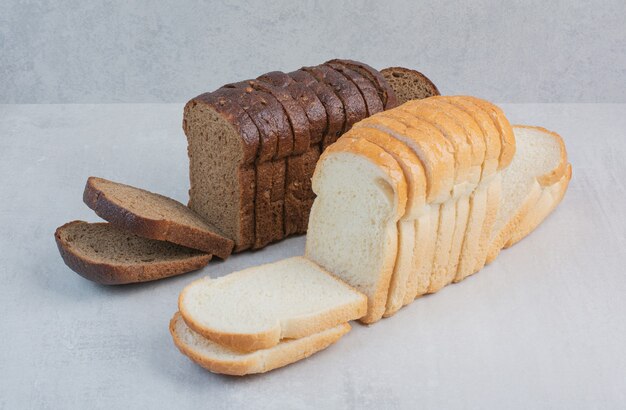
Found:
[54,221,211,285]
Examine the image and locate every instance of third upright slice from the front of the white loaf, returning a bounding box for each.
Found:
[355,107,455,305]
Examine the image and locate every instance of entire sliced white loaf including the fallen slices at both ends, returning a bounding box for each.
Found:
[170,96,571,374]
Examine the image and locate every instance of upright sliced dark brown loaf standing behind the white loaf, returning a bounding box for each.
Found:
[183,59,438,251]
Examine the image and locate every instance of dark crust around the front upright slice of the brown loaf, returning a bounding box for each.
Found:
[183,89,261,252]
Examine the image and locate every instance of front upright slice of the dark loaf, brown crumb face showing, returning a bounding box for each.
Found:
[183,89,260,251]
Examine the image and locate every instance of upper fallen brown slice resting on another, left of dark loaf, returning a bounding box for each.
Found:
[83,177,234,259]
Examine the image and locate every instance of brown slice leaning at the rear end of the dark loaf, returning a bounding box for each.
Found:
[380,67,440,104]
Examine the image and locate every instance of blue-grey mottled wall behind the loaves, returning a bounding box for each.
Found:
[0,0,626,103]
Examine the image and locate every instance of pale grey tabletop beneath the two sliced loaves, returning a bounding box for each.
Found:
[0,104,626,409]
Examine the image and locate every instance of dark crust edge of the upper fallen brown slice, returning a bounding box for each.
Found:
[83,177,234,259]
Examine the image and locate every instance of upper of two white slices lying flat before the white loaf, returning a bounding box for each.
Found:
[178,256,367,351]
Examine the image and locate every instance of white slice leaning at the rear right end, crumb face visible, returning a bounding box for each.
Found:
[487,126,568,263]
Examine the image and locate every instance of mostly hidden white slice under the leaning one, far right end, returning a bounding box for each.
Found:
[504,164,572,249]
